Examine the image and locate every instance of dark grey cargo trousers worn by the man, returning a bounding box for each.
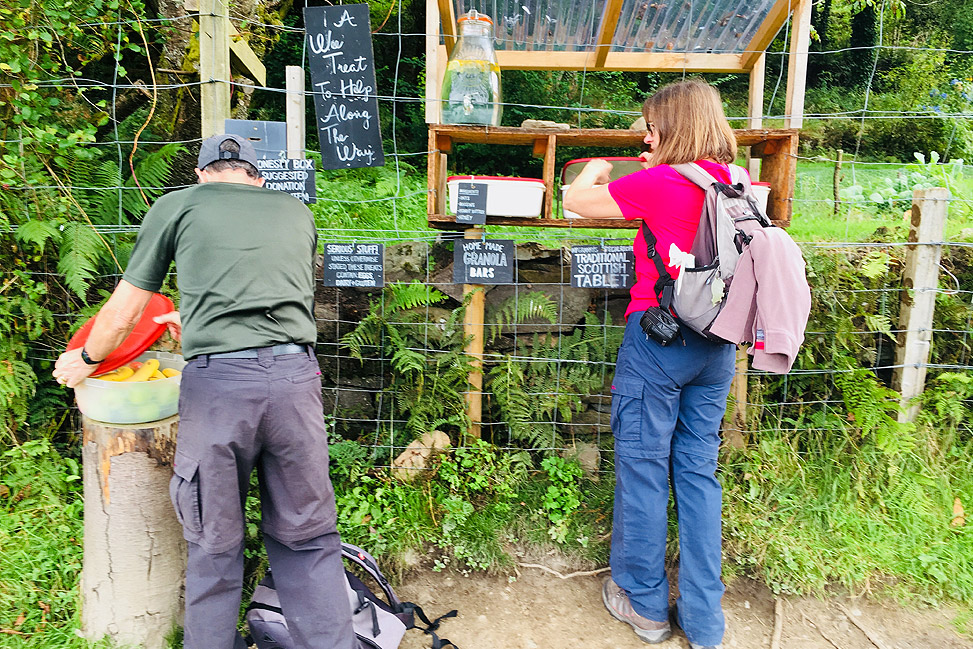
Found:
[170,348,356,649]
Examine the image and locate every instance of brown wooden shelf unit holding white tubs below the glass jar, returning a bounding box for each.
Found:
[427,124,799,230]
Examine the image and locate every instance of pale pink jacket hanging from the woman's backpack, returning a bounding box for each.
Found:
[710,228,811,374]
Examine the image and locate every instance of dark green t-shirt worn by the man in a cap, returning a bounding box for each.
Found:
[124,183,317,358]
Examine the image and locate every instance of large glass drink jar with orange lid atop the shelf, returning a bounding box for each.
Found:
[442,10,503,126]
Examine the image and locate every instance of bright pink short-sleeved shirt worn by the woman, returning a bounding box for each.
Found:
[608,160,730,318]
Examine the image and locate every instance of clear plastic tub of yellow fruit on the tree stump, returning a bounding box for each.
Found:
[74,352,186,424]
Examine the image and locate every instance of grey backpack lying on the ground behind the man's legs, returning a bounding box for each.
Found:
[246,543,456,649]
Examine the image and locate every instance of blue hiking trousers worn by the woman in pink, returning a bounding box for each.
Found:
[611,311,736,646]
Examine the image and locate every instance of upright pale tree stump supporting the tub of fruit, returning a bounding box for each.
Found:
[81,416,186,649]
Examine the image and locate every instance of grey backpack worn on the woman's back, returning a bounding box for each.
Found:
[641,162,773,342]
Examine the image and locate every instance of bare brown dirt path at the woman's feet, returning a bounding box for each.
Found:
[397,568,973,649]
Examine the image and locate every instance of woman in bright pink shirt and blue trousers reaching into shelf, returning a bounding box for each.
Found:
[564,80,736,649]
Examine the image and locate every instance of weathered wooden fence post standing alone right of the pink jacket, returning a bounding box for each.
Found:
[892,187,949,422]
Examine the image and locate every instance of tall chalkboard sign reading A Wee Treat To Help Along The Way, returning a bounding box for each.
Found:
[304,4,385,169]
